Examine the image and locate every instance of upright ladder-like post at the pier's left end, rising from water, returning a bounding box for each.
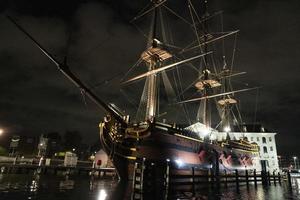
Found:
[131,158,145,200]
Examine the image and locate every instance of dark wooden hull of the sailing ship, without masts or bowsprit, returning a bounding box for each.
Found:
[99,120,258,181]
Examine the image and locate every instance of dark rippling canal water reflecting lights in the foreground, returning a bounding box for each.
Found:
[0,174,300,200]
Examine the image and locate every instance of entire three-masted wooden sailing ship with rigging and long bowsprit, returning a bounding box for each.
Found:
[11,0,259,180]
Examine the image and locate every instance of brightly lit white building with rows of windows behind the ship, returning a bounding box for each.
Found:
[187,123,279,173]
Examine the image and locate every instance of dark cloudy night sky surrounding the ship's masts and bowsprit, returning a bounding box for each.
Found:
[0,0,300,155]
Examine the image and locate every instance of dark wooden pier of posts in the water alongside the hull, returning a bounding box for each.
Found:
[132,160,291,199]
